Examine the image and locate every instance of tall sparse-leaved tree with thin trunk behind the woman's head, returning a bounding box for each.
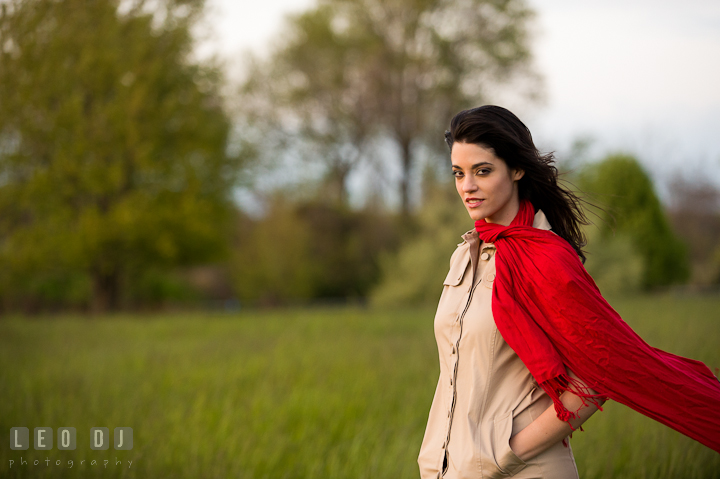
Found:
[244,0,532,214]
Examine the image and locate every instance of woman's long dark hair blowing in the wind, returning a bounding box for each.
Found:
[445,105,589,263]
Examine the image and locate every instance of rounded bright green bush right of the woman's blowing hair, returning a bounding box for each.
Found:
[579,155,690,288]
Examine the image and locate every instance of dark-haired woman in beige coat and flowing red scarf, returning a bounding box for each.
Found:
[418,106,720,479]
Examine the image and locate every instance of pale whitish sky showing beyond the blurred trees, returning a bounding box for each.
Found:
[200,0,720,201]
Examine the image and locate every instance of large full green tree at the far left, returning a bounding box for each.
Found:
[0,0,239,311]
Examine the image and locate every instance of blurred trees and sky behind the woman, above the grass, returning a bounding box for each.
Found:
[0,0,720,313]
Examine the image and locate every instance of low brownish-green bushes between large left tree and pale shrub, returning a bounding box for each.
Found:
[233,195,397,304]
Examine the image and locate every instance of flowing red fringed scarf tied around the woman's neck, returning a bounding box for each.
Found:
[475,200,720,452]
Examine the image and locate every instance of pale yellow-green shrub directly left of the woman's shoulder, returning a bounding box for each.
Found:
[371,178,473,306]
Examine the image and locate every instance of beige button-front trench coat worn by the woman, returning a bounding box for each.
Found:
[418,211,578,479]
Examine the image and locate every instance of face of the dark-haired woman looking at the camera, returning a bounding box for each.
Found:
[450,142,525,226]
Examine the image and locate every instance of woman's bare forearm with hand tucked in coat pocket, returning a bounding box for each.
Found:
[510,371,603,460]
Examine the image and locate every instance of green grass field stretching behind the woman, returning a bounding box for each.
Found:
[0,296,720,479]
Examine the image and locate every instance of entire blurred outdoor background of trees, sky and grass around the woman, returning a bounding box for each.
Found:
[0,0,720,478]
